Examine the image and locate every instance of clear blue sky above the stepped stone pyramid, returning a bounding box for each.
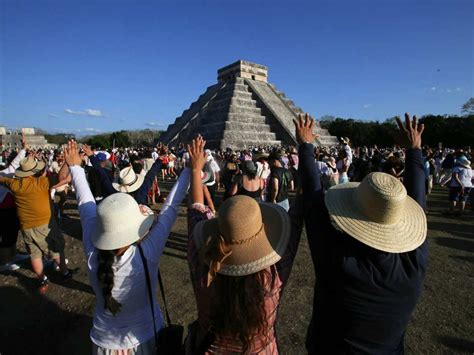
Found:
[0,0,474,134]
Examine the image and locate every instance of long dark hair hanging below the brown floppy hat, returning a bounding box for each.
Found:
[211,267,276,354]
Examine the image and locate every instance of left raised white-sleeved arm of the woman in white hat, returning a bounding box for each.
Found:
[64,141,97,254]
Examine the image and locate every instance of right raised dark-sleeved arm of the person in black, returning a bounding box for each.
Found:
[397,113,426,209]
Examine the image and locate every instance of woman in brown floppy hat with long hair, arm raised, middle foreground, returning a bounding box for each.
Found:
[186,136,302,354]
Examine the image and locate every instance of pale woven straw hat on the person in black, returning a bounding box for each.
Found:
[325,172,427,253]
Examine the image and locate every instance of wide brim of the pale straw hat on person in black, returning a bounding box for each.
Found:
[325,182,427,253]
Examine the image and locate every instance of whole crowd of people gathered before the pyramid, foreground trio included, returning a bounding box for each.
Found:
[0,114,474,354]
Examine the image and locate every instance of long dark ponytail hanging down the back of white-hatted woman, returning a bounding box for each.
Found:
[97,249,122,315]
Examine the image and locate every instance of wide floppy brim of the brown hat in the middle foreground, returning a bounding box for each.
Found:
[193,203,291,276]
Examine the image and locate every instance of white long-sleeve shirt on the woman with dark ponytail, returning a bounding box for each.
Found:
[71,166,190,349]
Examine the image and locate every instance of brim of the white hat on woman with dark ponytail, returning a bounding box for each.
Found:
[91,216,154,250]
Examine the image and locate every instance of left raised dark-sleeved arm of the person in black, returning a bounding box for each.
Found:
[293,114,322,201]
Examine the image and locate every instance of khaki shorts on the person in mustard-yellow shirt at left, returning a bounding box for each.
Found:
[21,221,64,259]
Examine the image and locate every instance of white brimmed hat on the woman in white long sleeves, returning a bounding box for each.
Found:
[91,193,154,250]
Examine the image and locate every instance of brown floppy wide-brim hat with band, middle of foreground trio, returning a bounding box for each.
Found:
[193,195,291,276]
